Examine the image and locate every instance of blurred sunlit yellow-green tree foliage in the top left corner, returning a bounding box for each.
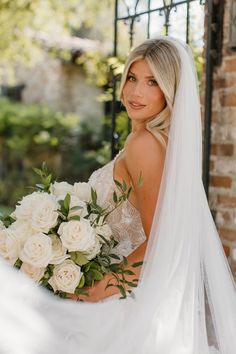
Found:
[0,0,113,77]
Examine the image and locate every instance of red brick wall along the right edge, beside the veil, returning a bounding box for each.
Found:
[202,0,236,275]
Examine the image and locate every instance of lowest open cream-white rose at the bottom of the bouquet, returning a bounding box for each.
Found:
[48,260,83,294]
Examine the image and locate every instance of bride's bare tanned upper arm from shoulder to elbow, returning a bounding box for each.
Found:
[125,130,165,236]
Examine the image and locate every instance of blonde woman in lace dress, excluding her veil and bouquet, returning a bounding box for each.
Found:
[76,37,171,301]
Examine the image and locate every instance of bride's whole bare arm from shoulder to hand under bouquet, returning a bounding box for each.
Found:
[71,131,165,302]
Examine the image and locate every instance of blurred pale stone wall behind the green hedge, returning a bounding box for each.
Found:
[16,54,103,129]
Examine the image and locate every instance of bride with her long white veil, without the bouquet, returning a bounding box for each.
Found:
[0,36,236,354]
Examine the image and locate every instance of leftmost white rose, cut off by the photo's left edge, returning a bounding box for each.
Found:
[0,229,20,265]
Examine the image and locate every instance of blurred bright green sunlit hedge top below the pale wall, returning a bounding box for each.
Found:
[0,99,79,156]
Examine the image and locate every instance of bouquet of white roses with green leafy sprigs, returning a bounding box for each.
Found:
[0,164,143,299]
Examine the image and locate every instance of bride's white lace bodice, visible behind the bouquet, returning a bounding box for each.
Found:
[88,150,146,257]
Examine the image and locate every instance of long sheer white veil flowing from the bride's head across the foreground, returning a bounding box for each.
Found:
[0,36,236,354]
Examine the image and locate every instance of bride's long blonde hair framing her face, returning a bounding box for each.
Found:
[120,39,181,148]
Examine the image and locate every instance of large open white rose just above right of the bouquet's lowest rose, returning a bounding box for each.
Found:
[58,219,96,252]
